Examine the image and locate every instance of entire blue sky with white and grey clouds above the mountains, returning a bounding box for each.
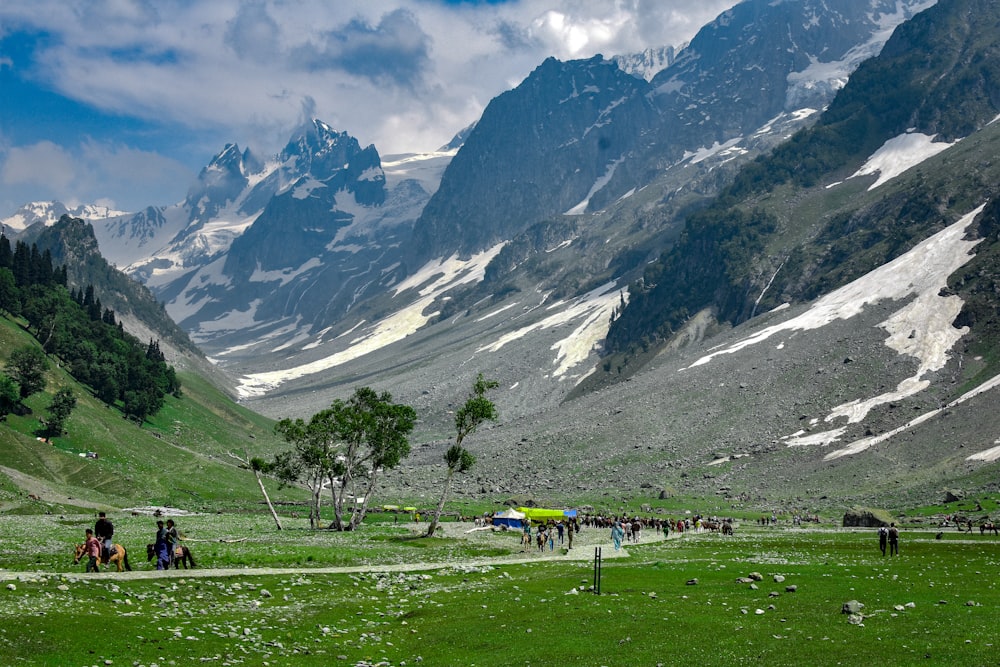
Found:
[0,0,735,217]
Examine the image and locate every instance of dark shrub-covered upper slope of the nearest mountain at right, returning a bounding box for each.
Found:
[608,0,1000,376]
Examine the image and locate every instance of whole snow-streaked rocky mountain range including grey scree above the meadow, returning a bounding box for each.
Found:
[7,0,1000,504]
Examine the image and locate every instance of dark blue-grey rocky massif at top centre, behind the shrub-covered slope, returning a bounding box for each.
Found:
[404,0,932,264]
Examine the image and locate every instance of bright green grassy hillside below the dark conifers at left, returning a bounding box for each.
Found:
[0,318,302,513]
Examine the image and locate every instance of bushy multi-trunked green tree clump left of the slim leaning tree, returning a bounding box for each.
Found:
[274,387,416,531]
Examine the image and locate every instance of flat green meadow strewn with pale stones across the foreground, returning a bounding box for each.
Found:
[0,513,1000,666]
